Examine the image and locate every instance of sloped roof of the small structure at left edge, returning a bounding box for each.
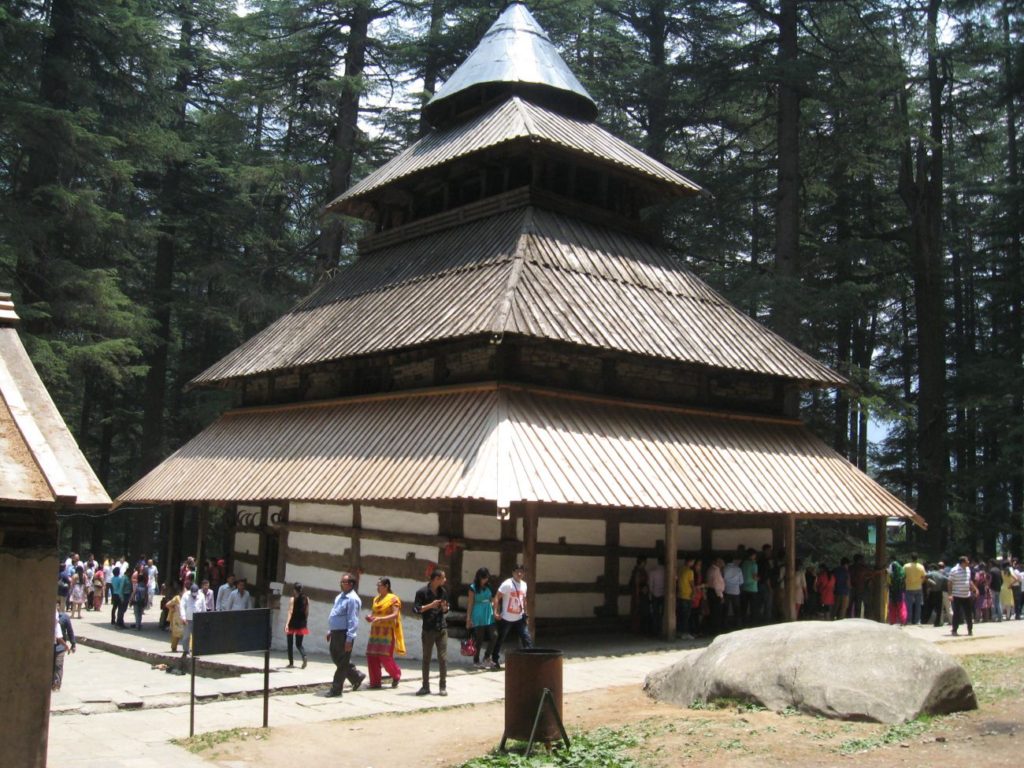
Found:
[0,294,111,508]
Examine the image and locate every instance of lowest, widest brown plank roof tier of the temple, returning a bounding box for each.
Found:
[118,383,924,526]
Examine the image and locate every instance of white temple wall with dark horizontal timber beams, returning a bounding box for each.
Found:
[236,503,772,664]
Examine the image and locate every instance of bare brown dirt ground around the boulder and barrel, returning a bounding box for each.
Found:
[200,633,1024,768]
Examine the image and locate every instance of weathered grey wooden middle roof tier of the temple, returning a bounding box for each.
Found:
[191,201,845,385]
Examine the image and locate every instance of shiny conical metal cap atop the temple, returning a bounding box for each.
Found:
[423,3,597,126]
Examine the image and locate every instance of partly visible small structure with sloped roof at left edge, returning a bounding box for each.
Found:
[0,293,111,768]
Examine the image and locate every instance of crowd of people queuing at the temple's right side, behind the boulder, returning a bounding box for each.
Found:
[630,545,1024,639]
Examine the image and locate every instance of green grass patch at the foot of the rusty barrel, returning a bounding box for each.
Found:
[459,721,665,768]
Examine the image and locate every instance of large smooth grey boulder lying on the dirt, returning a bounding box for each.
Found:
[644,618,978,723]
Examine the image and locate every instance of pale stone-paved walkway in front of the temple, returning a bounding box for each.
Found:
[47,612,1024,768]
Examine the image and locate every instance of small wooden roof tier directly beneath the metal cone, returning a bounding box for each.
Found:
[328,96,700,216]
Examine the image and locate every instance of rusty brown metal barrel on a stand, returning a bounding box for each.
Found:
[503,648,562,742]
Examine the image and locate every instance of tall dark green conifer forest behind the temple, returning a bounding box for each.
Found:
[0,0,1024,554]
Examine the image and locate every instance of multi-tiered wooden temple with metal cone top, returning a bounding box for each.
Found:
[118,4,923,654]
